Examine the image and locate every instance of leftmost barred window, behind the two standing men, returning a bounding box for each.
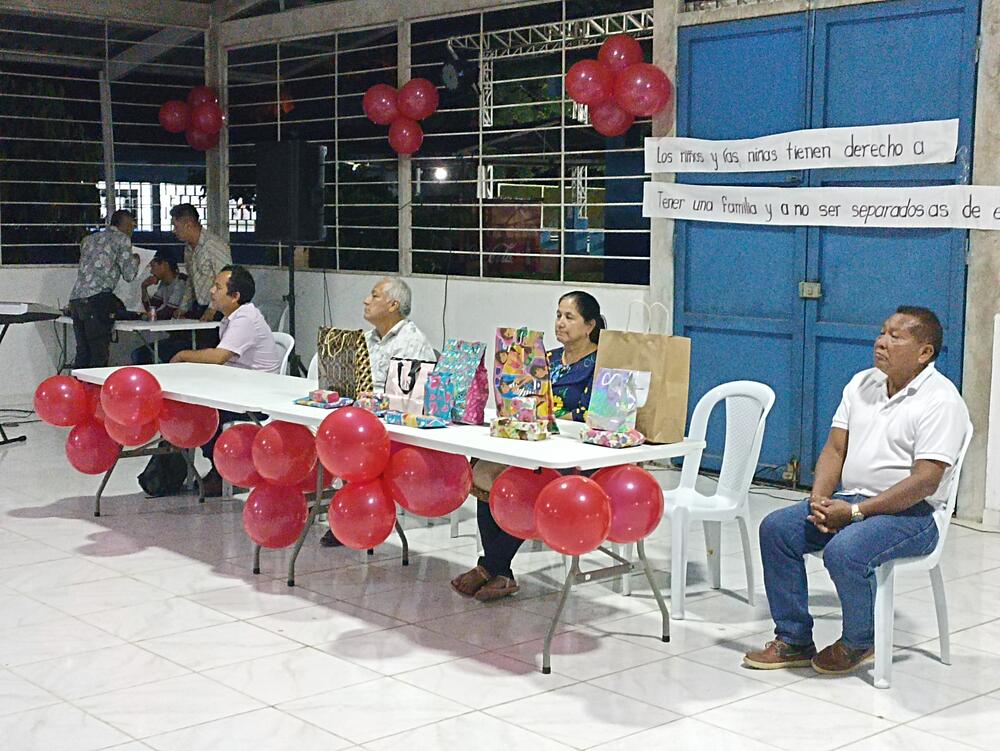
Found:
[0,13,205,265]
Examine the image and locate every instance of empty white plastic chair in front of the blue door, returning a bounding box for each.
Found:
[623,381,774,620]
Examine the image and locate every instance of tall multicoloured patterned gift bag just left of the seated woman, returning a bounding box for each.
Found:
[493,328,557,432]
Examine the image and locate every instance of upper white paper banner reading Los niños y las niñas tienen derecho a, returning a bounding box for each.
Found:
[646,119,958,174]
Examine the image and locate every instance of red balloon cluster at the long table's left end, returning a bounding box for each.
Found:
[34,368,219,475]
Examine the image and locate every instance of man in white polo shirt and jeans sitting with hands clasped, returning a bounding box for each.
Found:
[743,306,969,674]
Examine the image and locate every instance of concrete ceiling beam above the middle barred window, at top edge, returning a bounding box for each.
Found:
[220,0,537,49]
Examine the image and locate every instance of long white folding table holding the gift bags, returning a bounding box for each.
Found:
[73,363,705,673]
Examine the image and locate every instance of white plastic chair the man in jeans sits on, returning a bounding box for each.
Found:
[814,422,972,688]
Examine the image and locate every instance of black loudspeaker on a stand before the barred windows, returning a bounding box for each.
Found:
[255,141,326,245]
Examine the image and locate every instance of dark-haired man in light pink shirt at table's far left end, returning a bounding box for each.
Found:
[170,266,281,496]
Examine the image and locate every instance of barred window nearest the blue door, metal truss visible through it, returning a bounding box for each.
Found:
[411,0,653,284]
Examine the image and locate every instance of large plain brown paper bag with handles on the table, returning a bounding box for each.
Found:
[595,329,691,443]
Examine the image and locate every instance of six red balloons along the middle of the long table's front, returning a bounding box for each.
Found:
[214,407,472,550]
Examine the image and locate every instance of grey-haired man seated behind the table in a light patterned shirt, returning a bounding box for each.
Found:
[319,276,437,548]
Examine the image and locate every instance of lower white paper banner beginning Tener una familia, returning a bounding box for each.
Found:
[642,182,1000,230]
